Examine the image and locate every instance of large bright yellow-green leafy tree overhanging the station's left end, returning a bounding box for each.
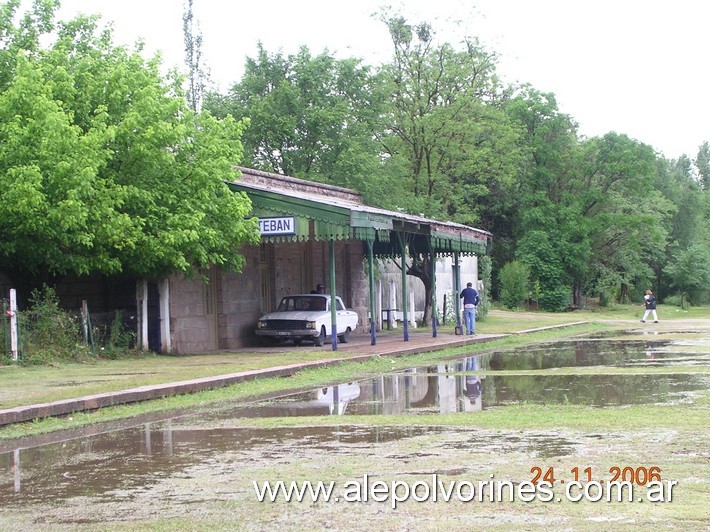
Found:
[0,0,258,276]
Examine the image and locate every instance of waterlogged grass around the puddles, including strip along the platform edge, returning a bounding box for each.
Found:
[0,313,710,531]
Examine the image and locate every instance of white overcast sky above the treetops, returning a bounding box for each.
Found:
[52,0,710,158]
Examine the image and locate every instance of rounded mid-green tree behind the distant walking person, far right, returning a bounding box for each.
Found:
[572,133,674,300]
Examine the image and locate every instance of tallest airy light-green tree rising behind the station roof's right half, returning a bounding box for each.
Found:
[381,15,519,322]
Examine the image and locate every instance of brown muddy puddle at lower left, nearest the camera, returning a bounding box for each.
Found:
[0,420,439,505]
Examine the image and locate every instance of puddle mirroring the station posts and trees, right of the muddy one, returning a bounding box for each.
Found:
[231,339,710,417]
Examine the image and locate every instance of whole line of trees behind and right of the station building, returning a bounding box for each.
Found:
[205,13,710,310]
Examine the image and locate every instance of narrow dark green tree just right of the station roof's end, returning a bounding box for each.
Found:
[507,89,590,311]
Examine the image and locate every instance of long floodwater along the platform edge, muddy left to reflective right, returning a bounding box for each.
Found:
[0,335,710,507]
